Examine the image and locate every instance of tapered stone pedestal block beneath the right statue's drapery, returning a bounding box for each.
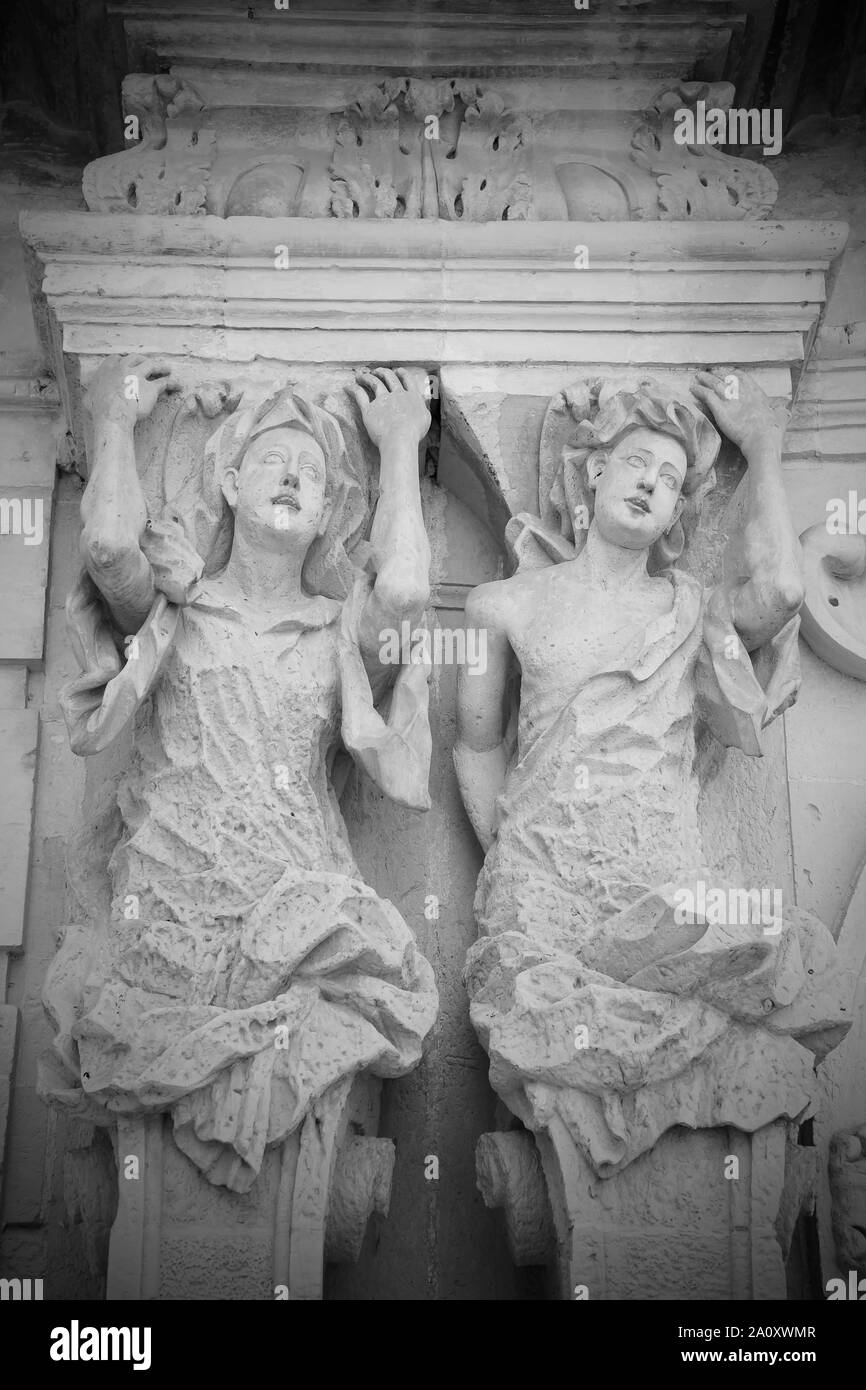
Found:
[477,1119,800,1302]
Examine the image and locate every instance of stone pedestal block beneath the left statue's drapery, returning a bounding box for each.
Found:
[107,1076,395,1302]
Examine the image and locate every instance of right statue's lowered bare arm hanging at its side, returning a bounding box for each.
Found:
[455,582,514,851]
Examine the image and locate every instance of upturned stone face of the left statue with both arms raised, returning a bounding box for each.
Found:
[222,425,329,549]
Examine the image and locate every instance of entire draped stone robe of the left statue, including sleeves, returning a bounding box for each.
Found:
[43,574,436,1191]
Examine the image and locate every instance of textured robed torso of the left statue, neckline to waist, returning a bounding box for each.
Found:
[113,584,354,924]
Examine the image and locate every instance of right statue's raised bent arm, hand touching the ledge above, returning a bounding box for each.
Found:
[692,371,803,651]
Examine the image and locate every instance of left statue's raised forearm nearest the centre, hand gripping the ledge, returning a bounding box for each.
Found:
[353,367,430,670]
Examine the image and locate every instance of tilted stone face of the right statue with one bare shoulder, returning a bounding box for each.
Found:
[587,428,688,550]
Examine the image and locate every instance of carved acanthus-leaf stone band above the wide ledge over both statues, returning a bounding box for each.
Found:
[83,74,776,222]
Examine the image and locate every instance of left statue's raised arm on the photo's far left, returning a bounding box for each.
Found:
[81,357,172,632]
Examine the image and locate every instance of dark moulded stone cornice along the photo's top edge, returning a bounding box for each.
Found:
[108,0,742,76]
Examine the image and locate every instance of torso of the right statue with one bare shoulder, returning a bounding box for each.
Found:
[477,566,703,948]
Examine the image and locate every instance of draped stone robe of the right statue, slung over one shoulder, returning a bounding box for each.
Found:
[464,517,851,1177]
